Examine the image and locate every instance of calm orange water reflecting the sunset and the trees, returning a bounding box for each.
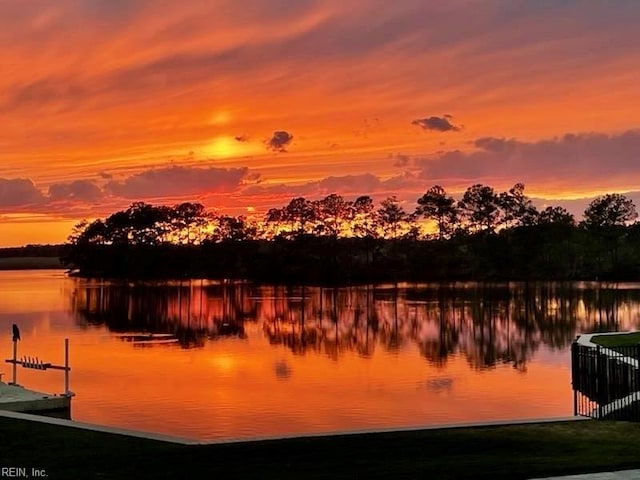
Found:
[0,271,640,439]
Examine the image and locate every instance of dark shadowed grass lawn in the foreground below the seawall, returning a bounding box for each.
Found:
[0,418,640,480]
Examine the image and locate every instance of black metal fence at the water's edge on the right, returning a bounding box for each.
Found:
[571,342,640,421]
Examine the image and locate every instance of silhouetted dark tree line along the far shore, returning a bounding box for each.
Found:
[63,183,640,283]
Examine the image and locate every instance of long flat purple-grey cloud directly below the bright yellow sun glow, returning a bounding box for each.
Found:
[105,166,249,199]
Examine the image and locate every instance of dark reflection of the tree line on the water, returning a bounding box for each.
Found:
[70,279,640,370]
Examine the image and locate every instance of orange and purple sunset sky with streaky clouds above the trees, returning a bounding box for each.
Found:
[0,0,640,246]
